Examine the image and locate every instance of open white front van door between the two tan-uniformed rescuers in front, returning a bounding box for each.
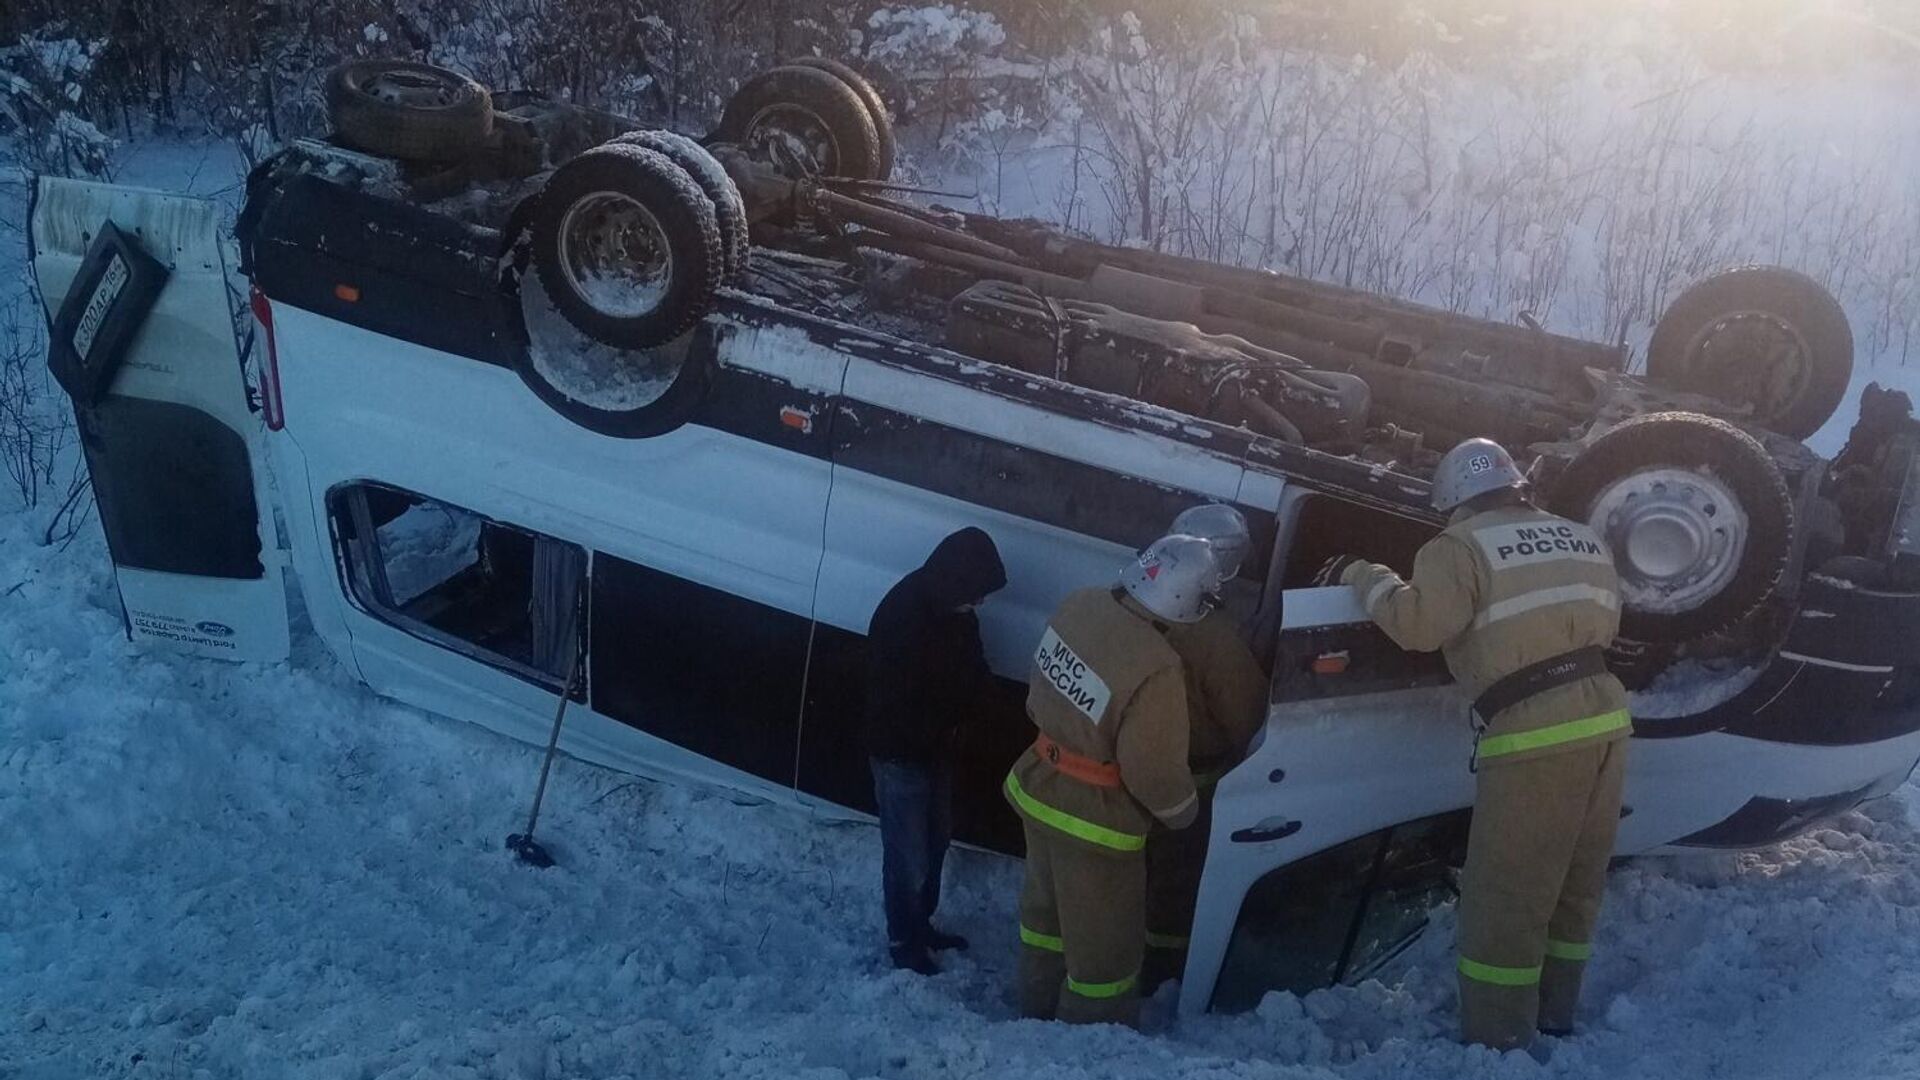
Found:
[1181,588,1473,1015]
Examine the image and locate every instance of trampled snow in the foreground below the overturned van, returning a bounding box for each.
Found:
[11,148,1920,1080]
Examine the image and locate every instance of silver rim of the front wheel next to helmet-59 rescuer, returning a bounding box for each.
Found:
[1588,469,1751,615]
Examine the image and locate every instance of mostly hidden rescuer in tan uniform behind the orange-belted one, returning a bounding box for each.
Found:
[1140,503,1267,994]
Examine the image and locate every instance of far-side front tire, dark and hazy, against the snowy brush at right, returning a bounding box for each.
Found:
[1647,267,1853,438]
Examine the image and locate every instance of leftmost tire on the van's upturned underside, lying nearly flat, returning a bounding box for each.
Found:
[326,60,493,161]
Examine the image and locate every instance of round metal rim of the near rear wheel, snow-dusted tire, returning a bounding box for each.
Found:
[559,192,674,319]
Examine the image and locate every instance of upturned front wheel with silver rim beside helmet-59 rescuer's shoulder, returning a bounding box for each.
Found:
[1549,413,1793,644]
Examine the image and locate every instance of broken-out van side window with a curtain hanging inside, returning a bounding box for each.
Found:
[328,484,586,686]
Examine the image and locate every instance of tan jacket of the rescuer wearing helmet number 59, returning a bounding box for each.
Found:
[1346,505,1632,765]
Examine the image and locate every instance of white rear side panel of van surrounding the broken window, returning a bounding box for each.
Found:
[273,304,848,801]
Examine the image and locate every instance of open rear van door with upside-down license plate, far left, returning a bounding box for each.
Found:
[31,179,288,661]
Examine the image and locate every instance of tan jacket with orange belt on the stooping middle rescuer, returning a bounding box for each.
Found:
[1006,588,1196,853]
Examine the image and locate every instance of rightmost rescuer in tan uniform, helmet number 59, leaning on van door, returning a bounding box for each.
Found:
[1342,438,1632,1049]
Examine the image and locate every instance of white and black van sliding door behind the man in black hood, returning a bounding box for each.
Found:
[801,357,1271,851]
